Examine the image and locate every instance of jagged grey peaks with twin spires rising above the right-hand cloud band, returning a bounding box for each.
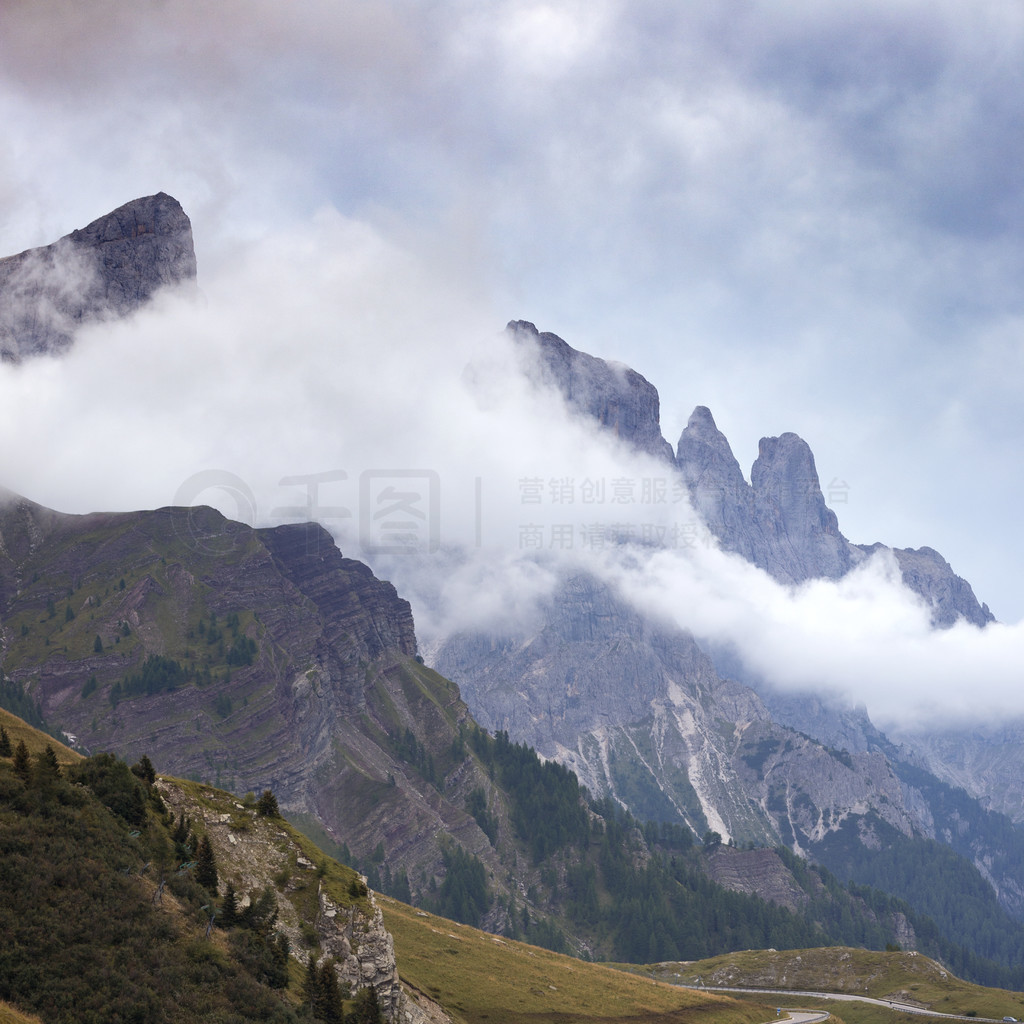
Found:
[495,321,993,627]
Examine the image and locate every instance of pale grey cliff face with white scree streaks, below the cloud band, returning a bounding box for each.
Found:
[436,577,927,850]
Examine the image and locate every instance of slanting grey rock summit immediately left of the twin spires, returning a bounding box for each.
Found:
[506,321,672,462]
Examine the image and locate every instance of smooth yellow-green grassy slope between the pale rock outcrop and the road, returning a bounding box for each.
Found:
[379,897,774,1024]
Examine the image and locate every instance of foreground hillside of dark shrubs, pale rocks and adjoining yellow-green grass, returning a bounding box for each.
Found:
[0,711,765,1024]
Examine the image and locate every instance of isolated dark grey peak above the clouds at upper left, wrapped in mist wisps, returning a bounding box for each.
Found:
[0,193,196,361]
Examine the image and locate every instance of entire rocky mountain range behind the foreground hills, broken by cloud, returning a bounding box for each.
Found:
[6,195,1024,987]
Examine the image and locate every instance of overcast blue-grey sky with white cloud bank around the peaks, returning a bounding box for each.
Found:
[0,0,1024,724]
